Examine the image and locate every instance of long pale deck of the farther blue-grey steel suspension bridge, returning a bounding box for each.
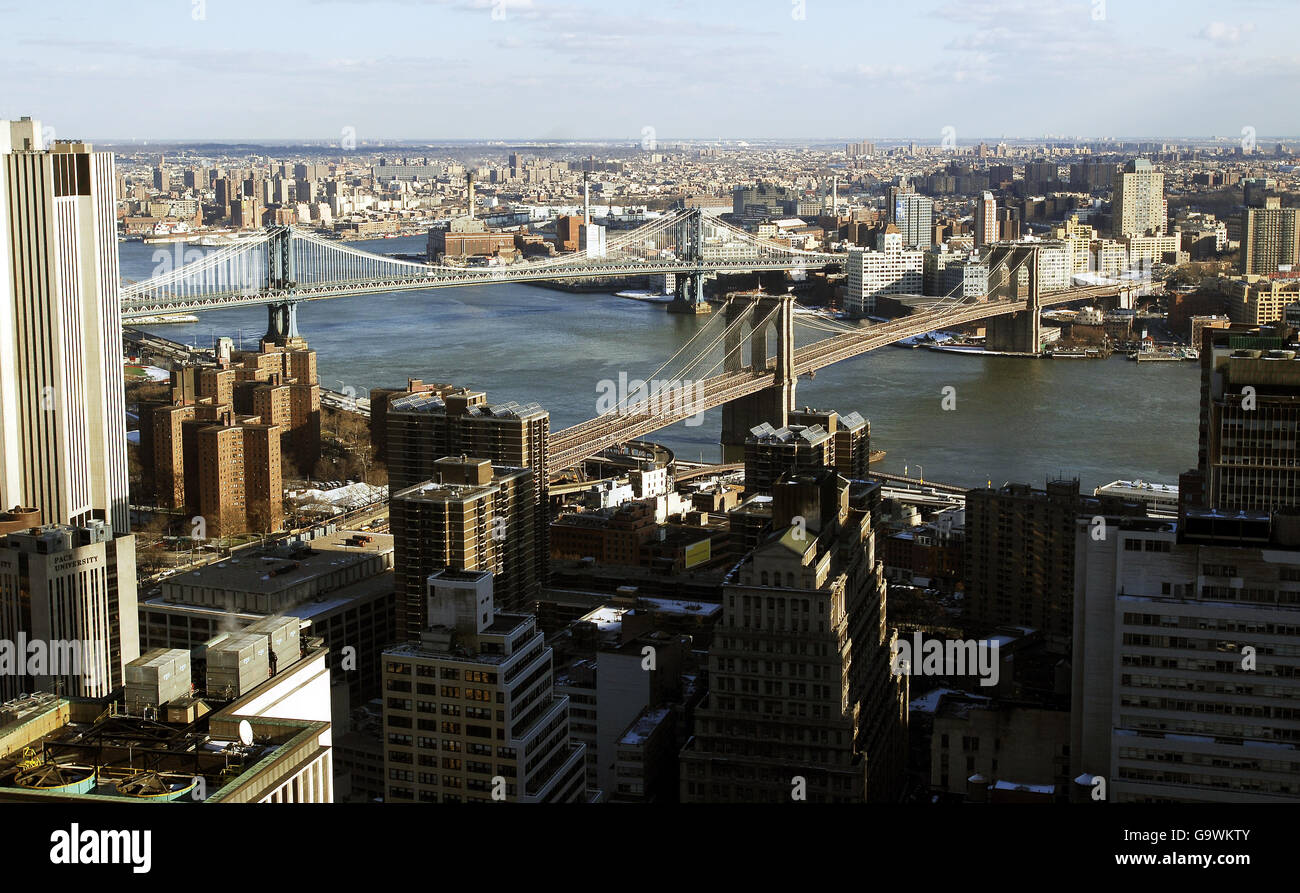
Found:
[122,255,846,322]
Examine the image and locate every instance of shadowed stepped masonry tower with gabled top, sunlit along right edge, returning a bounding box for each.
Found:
[680,469,907,803]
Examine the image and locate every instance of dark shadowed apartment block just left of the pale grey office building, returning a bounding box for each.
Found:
[966,480,1145,654]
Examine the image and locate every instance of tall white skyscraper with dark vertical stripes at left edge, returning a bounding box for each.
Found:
[0,118,130,534]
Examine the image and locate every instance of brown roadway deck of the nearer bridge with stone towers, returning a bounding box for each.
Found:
[550,285,1122,472]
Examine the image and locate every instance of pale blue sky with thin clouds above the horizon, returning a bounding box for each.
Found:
[0,0,1300,144]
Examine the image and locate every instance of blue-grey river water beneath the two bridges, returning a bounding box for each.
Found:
[118,232,1199,491]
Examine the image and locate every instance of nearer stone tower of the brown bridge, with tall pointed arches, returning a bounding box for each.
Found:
[722,294,796,463]
